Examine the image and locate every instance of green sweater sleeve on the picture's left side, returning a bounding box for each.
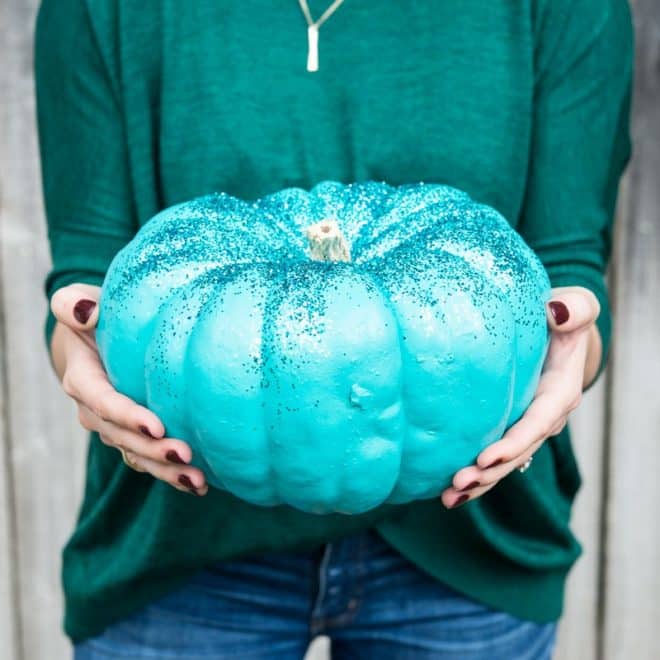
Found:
[35,0,137,346]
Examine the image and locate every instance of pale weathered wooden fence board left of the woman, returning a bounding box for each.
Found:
[0,0,89,660]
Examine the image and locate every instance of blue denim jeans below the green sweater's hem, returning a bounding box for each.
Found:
[75,532,556,660]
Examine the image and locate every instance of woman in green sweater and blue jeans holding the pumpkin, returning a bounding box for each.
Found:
[36,0,632,660]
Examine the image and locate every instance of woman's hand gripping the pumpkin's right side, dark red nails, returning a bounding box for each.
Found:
[441,286,602,508]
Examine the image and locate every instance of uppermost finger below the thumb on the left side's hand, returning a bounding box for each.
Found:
[62,351,165,438]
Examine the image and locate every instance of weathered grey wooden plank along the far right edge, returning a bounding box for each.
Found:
[603,0,660,658]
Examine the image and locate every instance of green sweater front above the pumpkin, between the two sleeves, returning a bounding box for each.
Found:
[102,0,534,225]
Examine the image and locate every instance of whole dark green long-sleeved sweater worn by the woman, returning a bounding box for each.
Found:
[36,0,632,640]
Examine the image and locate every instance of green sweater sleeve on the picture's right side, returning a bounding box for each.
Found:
[519,0,633,382]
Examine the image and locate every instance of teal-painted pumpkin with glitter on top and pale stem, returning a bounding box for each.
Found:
[96,181,549,513]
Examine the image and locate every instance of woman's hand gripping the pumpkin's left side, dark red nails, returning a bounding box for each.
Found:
[51,284,208,495]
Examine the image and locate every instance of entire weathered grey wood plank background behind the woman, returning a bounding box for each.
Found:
[0,0,660,660]
